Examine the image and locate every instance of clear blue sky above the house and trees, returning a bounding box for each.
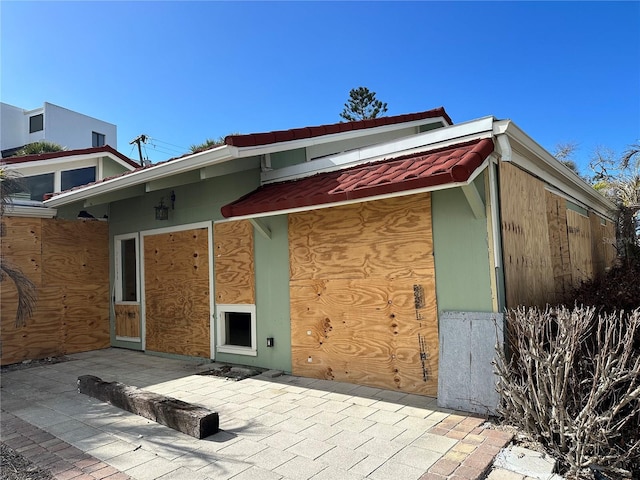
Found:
[0,0,640,171]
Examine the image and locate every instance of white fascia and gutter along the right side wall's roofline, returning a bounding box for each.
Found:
[494,120,616,218]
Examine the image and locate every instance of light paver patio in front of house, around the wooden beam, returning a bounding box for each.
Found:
[0,349,511,480]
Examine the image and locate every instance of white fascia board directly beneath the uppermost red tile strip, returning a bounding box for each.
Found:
[238,117,449,156]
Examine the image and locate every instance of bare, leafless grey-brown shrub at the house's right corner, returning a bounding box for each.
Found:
[496,307,640,478]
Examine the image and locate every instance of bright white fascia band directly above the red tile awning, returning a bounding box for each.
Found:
[261,117,494,184]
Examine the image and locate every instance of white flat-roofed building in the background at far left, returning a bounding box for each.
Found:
[0,102,118,158]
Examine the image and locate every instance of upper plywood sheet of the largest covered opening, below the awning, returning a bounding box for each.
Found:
[289,194,434,280]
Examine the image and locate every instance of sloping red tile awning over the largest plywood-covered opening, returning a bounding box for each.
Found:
[222,138,494,218]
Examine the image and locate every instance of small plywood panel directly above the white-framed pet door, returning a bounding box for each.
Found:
[213,220,256,305]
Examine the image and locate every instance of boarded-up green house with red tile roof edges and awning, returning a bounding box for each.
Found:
[2,108,615,408]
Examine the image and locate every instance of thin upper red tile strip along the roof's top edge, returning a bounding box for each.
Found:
[224,107,453,147]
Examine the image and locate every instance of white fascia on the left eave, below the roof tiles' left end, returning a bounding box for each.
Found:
[44,145,237,207]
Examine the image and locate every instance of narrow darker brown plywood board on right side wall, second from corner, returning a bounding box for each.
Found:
[545,191,572,299]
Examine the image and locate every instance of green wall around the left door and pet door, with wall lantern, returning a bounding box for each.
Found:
[109,170,291,372]
